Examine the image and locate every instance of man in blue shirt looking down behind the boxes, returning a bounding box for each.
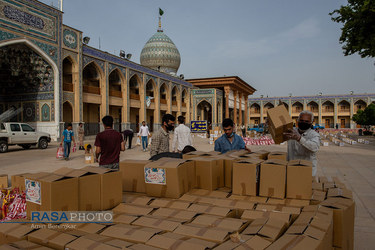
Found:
[215,118,246,154]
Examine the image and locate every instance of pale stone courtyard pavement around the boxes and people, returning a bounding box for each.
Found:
[0,137,375,249]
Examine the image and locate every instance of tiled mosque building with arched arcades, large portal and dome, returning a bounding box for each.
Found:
[0,0,374,140]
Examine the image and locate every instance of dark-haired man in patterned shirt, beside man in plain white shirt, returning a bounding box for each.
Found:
[150,114,176,157]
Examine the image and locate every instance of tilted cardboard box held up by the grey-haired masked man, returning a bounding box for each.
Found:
[267,105,293,144]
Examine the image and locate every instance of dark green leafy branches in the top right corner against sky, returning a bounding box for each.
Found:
[329,0,375,58]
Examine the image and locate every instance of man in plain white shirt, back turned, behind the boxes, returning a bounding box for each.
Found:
[172,115,193,153]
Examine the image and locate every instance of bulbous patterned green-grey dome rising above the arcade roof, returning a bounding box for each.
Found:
[140,31,181,74]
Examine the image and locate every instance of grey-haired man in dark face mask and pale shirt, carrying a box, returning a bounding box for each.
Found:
[284,111,320,176]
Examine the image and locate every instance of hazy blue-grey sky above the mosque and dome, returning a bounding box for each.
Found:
[42,0,375,97]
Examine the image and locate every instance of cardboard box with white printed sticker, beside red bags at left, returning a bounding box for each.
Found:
[25,173,78,218]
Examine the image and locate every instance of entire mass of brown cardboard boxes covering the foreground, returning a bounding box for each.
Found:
[0,151,354,250]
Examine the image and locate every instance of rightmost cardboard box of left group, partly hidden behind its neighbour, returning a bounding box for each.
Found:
[82,166,122,210]
